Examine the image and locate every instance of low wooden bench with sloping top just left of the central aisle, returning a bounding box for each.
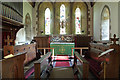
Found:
[34,52,53,79]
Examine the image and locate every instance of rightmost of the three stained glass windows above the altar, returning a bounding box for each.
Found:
[75,8,81,34]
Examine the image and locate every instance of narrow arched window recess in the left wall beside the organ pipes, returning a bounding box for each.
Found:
[25,13,32,42]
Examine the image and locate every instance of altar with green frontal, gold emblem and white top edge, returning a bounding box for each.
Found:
[50,43,75,56]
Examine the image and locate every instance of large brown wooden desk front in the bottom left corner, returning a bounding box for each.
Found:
[0,53,26,79]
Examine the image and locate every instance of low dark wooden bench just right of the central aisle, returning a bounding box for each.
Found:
[73,52,89,79]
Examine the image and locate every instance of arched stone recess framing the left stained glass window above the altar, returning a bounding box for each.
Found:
[37,2,54,36]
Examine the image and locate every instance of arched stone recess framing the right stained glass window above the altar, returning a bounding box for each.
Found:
[72,2,88,34]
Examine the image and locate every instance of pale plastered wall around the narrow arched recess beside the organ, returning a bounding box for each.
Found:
[15,2,34,45]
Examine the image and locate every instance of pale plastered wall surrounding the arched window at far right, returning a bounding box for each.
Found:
[93,2,118,41]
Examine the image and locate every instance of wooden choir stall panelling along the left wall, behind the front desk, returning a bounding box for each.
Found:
[4,43,36,65]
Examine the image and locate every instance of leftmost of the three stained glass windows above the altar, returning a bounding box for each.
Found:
[45,8,50,34]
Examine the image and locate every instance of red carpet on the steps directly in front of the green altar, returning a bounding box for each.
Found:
[55,56,70,67]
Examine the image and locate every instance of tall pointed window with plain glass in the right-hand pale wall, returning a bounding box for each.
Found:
[100,5,110,40]
